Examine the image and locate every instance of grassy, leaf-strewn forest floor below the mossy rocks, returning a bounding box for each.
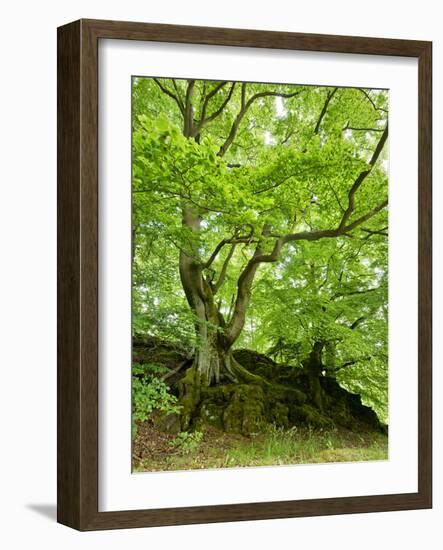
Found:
[133,421,388,472]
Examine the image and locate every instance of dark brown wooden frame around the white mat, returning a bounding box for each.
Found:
[57,20,432,531]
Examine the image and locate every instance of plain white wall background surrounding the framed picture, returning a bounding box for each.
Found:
[0,0,443,550]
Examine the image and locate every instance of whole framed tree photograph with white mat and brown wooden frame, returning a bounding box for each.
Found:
[58,20,432,530]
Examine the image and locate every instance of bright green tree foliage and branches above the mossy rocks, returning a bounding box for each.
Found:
[132,78,388,422]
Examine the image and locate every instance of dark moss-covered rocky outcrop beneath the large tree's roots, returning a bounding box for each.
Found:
[134,343,385,435]
